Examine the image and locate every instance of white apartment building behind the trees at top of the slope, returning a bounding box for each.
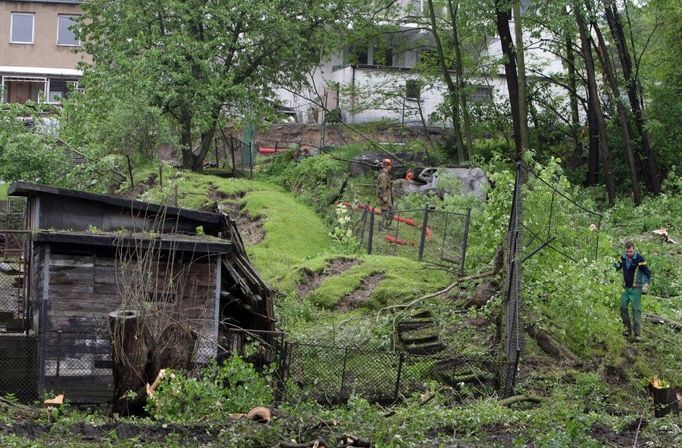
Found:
[278,0,564,125]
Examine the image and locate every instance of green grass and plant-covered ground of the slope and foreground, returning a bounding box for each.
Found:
[0,154,682,447]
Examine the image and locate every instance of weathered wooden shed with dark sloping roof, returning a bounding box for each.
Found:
[4,183,275,403]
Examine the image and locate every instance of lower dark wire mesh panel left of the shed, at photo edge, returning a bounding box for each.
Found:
[0,334,38,402]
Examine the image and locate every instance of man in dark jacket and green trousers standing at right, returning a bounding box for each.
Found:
[614,241,651,341]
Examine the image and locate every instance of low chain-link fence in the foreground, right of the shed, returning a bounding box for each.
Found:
[218,329,500,404]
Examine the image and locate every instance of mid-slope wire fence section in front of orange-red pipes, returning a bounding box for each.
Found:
[348,204,471,274]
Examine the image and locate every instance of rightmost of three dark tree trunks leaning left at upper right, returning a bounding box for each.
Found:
[604,0,661,194]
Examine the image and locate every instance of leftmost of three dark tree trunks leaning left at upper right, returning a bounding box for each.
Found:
[573,0,616,205]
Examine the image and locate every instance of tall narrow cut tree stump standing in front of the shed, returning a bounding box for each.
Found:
[109,310,149,415]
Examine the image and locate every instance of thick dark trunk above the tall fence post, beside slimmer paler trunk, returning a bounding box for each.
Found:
[495,0,523,160]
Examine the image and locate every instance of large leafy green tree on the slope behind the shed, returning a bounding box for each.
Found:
[82,0,361,169]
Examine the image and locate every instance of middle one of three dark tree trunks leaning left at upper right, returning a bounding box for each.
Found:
[585,9,642,205]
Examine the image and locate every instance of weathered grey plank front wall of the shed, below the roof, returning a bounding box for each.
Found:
[38,253,216,402]
